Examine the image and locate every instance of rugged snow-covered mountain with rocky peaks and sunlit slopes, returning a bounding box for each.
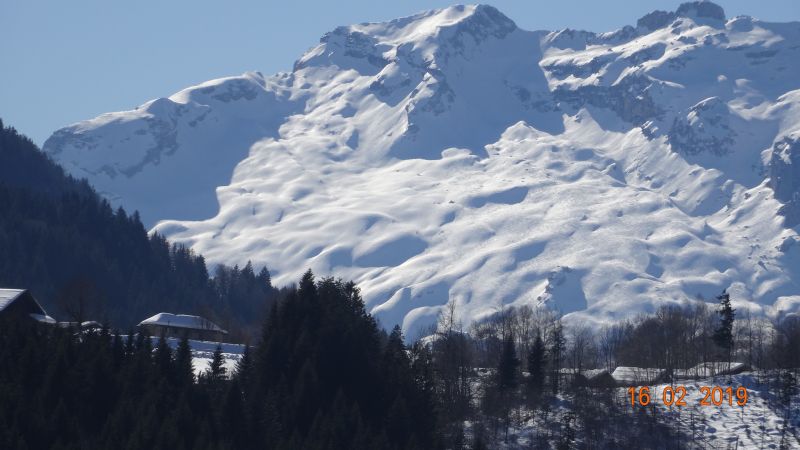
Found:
[44,2,800,337]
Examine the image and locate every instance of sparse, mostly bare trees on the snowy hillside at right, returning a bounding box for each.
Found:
[422,292,800,449]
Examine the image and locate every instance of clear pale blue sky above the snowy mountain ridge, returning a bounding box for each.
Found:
[0,0,800,145]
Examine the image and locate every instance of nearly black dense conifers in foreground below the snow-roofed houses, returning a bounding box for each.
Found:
[0,272,442,450]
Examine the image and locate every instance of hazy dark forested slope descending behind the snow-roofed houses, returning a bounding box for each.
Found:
[0,121,277,327]
